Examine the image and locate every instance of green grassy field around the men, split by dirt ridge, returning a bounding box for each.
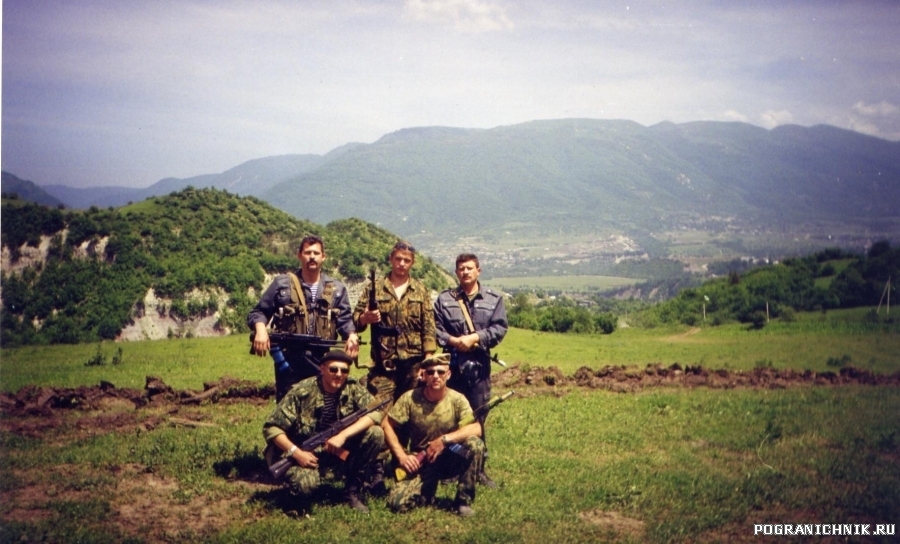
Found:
[0,312,900,544]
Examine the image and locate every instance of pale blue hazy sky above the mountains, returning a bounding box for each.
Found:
[0,0,900,187]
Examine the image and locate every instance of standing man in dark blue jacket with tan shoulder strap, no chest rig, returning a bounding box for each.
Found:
[434,253,509,488]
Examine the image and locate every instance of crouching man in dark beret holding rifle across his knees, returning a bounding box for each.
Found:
[263,351,384,513]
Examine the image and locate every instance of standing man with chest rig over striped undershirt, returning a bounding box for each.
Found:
[247,236,359,402]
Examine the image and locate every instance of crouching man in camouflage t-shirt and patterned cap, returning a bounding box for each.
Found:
[382,355,484,517]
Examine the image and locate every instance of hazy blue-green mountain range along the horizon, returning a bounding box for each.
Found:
[8,119,900,244]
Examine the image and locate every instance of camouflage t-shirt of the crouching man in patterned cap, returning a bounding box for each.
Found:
[388,387,472,452]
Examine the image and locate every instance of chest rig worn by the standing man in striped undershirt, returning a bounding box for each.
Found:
[272,272,338,340]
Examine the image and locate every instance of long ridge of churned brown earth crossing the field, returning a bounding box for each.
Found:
[0,363,900,420]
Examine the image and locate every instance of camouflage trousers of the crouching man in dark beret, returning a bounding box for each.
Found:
[285,425,384,498]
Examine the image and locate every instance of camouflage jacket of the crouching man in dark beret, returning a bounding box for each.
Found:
[263,377,381,444]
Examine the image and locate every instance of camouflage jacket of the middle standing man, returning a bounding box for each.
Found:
[353,276,437,365]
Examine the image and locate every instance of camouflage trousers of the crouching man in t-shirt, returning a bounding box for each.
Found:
[387,436,484,512]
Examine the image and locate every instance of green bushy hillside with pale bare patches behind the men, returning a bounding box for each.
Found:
[0,188,449,347]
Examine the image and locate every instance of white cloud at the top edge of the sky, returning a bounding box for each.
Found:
[406,0,513,32]
